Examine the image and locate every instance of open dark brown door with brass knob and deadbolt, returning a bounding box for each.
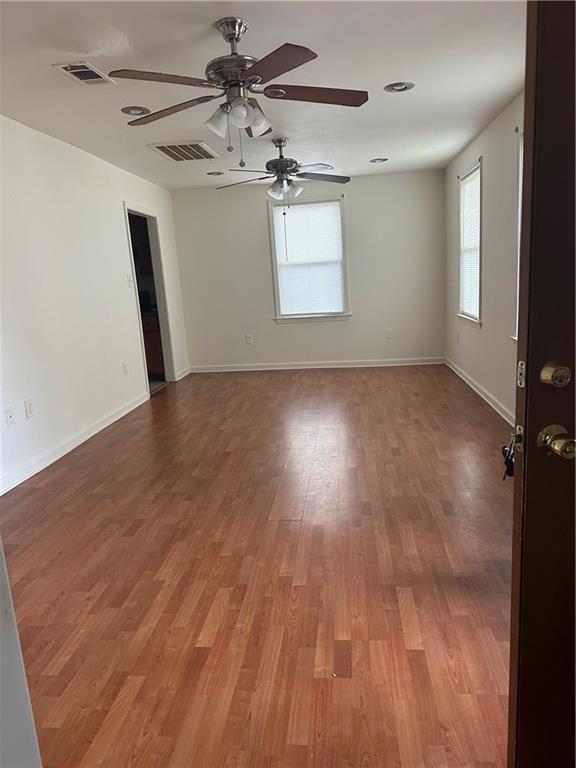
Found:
[509,2,575,768]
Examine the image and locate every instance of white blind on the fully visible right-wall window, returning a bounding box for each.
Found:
[460,166,481,320]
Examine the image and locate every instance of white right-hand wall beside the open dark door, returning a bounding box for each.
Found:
[446,94,524,421]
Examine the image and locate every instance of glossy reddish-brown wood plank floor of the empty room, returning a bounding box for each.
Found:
[1,366,512,768]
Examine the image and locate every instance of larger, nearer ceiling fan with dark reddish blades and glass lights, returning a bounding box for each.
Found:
[109,16,368,138]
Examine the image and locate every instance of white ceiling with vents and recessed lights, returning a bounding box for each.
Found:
[0,1,526,189]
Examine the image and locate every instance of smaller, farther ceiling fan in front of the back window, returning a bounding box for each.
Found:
[217,139,350,200]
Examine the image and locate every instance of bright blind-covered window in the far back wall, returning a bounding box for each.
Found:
[270,200,347,318]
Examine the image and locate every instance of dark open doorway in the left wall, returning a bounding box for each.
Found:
[128,211,166,395]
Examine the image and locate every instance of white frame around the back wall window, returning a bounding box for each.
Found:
[267,195,352,323]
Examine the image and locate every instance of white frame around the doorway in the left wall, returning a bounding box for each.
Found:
[122,200,177,390]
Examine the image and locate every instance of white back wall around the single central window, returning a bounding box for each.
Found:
[173,171,445,370]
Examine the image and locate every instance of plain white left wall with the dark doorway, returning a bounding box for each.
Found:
[0,118,188,490]
